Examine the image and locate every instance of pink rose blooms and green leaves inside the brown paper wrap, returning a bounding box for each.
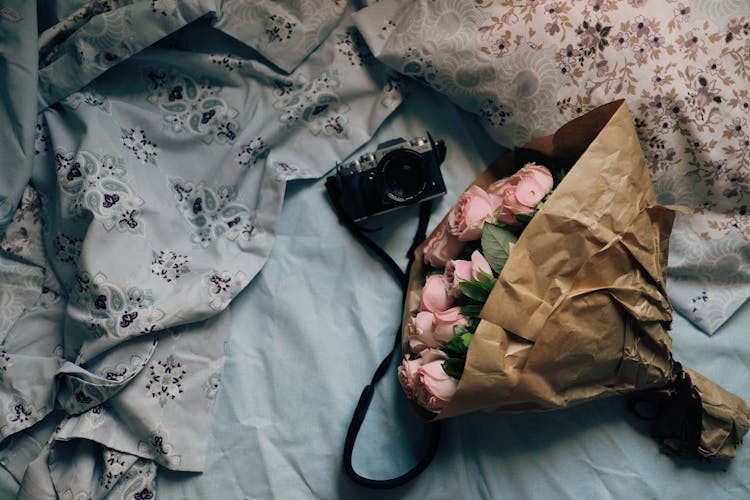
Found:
[398,162,562,412]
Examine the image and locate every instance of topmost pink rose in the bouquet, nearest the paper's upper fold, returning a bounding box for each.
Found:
[487,163,554,226]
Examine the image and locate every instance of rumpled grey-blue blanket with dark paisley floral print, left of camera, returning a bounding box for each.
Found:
[0,0,402,499]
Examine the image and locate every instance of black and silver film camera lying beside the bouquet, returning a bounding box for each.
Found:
[327,134,446,222]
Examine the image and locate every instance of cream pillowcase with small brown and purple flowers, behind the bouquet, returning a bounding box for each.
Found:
[357,0,750,334]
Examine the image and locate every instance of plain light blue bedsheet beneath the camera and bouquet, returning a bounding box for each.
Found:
[158,89,750,500]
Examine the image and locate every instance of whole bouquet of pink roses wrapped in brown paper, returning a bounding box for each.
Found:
[398,101,750,457]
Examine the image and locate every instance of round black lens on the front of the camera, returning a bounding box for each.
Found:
[380,150,427,203]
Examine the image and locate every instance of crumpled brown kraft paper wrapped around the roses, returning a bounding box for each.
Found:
[402,101,750,458]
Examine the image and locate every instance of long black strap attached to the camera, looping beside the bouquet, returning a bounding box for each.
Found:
[326,177,440,489]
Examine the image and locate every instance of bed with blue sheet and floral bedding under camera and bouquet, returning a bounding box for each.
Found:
[0,0,750,499]
